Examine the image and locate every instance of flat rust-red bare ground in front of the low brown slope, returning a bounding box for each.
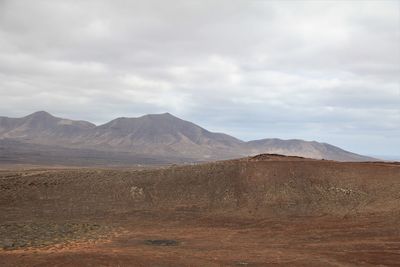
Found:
[0,212,400,267]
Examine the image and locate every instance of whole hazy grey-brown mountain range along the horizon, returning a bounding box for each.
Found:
[0,111,374,165]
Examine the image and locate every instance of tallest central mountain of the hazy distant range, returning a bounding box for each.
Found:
[87,113,243,158]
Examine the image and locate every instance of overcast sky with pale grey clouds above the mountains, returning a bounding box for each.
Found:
[0,0,400,155]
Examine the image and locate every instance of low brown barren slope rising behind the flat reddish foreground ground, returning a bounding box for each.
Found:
[1,154,400,220]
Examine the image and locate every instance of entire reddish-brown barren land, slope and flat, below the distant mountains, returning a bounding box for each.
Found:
[0,155,400,266]
